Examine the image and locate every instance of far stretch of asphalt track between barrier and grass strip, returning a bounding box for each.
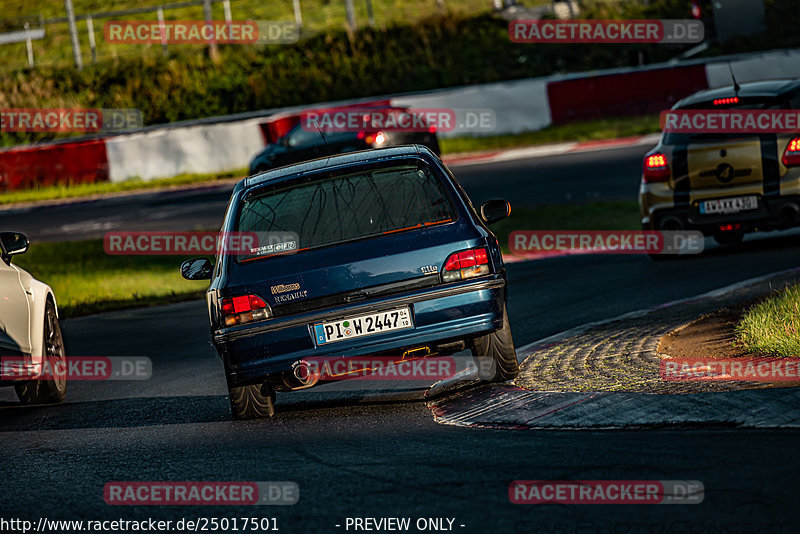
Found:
[0,146,649,241]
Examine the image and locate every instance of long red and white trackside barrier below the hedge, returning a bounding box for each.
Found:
[0,50,800,191]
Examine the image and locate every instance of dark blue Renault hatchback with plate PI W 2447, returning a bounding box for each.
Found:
[181,145,518,419]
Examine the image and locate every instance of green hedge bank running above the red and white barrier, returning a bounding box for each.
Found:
[0,0,800,145]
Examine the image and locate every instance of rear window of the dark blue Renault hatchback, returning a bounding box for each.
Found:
[238,164,456,261]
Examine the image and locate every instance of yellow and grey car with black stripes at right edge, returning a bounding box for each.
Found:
[639,80,800,248]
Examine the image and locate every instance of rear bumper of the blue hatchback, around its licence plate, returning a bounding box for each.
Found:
[213,275,506,385]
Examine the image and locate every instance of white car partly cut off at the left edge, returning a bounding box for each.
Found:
[0,232,67,404]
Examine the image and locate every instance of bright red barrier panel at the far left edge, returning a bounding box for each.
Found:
[0,139,108,191]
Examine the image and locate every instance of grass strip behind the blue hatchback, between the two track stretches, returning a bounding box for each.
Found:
[14,202,637,318]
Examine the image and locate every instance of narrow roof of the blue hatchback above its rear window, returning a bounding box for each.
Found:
[240,145,432,191]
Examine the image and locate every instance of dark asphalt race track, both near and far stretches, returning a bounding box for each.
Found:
[0,147,800,534]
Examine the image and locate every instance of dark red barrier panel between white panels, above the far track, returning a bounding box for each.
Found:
[547,65,708,124]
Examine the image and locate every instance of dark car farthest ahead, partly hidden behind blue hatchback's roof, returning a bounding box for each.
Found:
[250,107,440,175]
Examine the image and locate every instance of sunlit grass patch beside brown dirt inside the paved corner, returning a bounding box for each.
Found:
[736,285,800,356]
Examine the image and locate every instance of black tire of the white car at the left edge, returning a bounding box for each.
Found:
[14,300,67,404]
